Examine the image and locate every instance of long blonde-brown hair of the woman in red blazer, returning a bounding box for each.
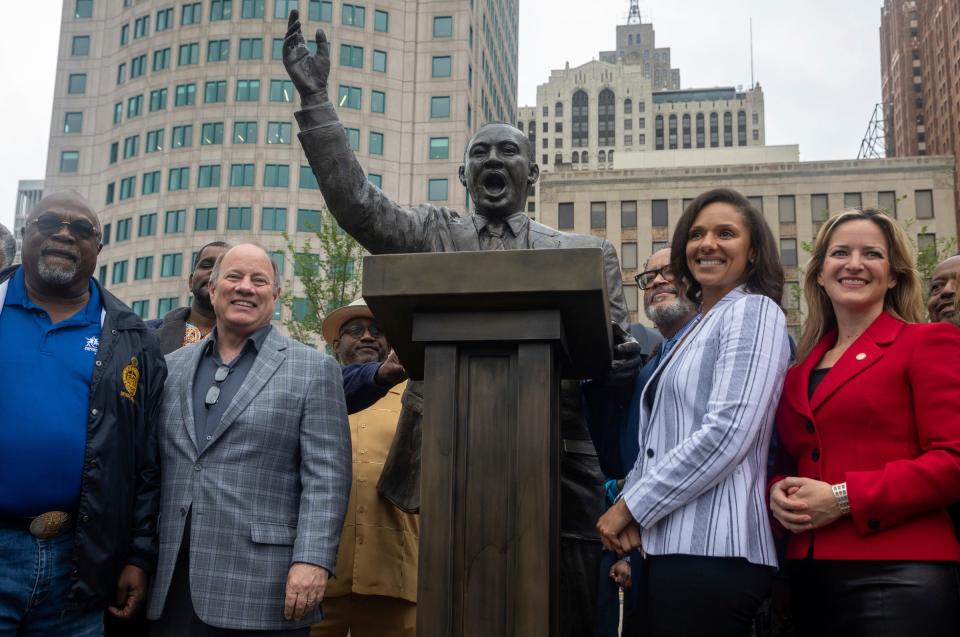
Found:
[797,208,923,361]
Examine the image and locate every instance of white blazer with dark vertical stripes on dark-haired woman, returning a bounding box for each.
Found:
[623,287,790,566]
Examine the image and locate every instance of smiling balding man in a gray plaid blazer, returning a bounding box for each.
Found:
[148,244,351,637]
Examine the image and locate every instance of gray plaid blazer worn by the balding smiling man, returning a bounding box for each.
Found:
[148,330,351,630]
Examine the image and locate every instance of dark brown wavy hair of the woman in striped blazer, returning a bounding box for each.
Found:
[670,188,783,305]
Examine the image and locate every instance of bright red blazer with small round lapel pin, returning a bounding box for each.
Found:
[774,313,960,561]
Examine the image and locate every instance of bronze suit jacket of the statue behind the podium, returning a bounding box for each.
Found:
[296,101,629,540]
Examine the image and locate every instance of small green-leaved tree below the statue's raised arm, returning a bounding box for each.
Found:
[281,209,364,347]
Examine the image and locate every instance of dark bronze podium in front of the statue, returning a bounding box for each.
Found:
[363,248,611,637]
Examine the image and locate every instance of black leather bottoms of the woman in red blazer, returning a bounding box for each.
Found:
[788,559,960,637]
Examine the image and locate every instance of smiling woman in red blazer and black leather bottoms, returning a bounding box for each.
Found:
[770,209,960,637]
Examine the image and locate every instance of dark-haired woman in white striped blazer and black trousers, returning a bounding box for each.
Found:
[597,189,790,636]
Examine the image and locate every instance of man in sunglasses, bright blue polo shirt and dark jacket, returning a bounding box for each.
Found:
[0,193,166,637]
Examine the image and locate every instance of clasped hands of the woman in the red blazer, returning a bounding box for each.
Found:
[770,477,842,533]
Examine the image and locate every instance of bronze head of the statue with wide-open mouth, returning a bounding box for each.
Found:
[460,124,540,217]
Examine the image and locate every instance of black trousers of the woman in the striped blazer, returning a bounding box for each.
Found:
[624,555,774,637]
